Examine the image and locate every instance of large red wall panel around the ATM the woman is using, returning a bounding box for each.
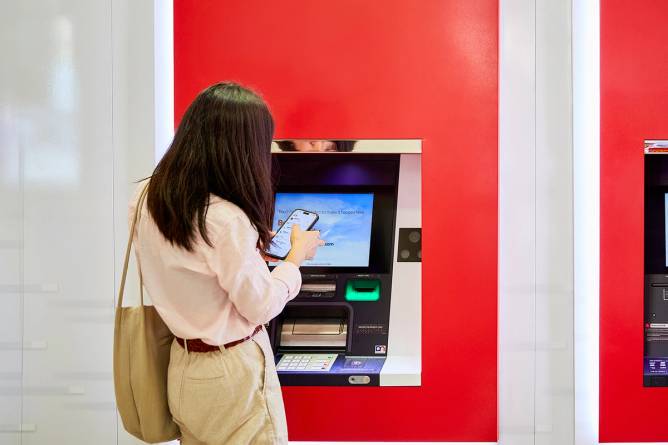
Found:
[174,0,498,441]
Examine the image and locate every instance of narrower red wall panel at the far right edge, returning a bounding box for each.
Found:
[600,0,668,442]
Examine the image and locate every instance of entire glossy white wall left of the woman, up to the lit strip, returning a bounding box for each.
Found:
[0,0,165,445]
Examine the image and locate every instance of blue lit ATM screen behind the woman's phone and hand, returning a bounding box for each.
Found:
[273,193,373,267]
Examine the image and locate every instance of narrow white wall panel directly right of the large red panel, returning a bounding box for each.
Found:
[499,0,536,445]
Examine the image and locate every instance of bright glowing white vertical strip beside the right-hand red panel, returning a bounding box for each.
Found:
[573,0,600,445]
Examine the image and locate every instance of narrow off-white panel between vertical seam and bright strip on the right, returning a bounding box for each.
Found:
[535,0,575,445]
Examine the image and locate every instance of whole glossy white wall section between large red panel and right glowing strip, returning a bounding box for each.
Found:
[499,0,575,445]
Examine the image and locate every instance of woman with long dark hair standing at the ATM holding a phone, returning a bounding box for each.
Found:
[130,83,323,445]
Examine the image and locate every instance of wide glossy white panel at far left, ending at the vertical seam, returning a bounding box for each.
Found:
[2,1,116,444]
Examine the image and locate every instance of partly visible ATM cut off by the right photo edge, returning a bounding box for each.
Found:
[643,140,668,386]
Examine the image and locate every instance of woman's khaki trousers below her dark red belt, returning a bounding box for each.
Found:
[167,329,288,445]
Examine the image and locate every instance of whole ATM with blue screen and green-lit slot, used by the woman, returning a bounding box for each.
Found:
[269,140,422,386]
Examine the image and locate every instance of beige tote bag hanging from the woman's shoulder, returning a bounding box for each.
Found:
[114,184,181,443]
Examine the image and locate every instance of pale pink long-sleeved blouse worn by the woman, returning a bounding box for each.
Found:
[129,183,301,345]
